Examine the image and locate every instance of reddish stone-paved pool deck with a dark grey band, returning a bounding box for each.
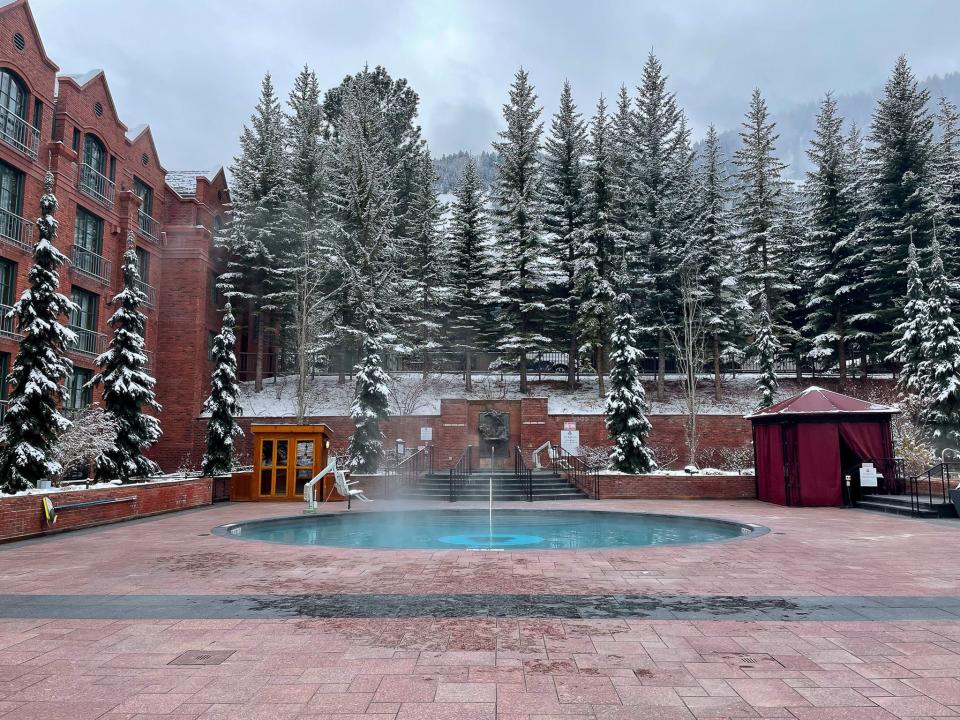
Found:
[0,501,960,720]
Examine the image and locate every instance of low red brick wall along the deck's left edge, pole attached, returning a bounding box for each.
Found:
[0,478,213,542]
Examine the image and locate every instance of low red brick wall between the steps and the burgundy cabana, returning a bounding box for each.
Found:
[600,475,757,500]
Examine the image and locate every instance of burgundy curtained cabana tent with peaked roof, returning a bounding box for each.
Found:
[747,387,899,506]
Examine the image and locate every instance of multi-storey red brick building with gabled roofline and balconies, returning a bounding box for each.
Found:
[0,0,228,469]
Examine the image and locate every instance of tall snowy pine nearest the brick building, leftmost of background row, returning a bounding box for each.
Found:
[219,73,290,392]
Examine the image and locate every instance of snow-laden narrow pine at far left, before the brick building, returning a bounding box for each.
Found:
[0,172,74,493]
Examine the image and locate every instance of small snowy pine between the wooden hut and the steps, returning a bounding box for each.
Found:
[347,307,390,473]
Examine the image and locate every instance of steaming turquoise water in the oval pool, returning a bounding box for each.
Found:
[215,509,766,550]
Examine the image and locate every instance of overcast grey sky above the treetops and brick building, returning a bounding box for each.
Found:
[31,0,960,170]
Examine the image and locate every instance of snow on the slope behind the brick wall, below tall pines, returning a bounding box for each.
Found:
[232,373,876,418]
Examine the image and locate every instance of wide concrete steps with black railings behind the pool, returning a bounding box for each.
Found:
[402,470,587,501]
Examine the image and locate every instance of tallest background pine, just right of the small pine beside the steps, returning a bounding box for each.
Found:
[626,53,695,400]
